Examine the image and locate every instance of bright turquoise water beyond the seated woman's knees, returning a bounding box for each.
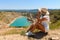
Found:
[10,17,31,26]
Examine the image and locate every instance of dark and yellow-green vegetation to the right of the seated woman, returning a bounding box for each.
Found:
[49,9,60,29]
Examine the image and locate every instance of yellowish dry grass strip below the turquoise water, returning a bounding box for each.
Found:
[0,28,26,35]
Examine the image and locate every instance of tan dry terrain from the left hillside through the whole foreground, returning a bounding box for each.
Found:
[0,12,60,40]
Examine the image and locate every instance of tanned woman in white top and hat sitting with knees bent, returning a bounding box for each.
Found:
[26,8,50,35]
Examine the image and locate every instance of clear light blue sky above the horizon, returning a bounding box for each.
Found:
[0,0,60,9]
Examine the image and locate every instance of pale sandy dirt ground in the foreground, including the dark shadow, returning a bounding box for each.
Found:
[0,29,60,40]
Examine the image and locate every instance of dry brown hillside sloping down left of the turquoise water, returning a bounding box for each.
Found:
[0,12,20,28]
